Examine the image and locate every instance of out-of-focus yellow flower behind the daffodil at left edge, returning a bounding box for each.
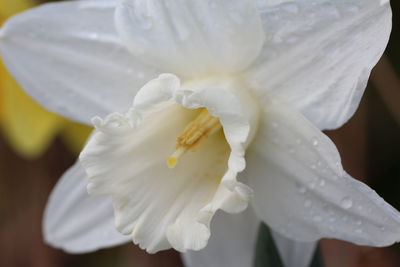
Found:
[0,0,91,158]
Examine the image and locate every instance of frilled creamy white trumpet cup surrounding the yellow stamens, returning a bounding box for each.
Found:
[81,74,260,252]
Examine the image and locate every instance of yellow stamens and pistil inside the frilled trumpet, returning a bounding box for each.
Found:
[167,108,222,169]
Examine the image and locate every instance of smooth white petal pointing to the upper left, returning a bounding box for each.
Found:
[0,0,162,123]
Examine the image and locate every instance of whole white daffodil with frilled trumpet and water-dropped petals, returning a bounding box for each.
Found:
[0,0,400,266]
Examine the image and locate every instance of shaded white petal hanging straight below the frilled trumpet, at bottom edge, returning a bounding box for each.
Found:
[182,208,260,267]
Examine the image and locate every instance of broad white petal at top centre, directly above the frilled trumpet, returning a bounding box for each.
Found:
[115,0,264,76]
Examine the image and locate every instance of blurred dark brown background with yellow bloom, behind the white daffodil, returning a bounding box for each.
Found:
[0,0,400,267]
